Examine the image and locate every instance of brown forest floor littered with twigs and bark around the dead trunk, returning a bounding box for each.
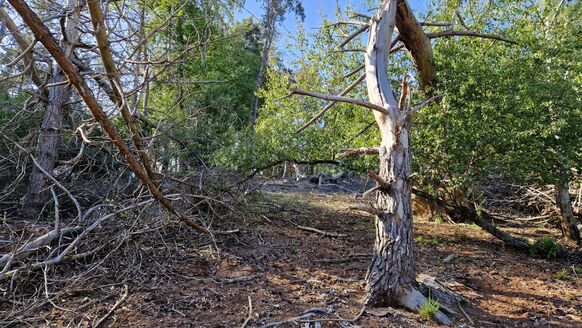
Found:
[0,179,582,327]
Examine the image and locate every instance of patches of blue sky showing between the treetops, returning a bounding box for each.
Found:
[235,0,428,62]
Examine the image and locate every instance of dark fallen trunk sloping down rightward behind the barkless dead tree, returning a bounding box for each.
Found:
[412,188,582,262]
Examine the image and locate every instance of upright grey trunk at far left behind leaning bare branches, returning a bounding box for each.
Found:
[20,0,81,218]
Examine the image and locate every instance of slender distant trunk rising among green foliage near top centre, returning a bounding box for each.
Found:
[250,0,278,135]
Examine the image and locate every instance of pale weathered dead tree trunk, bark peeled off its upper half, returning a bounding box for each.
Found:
[365,0,451,324]
